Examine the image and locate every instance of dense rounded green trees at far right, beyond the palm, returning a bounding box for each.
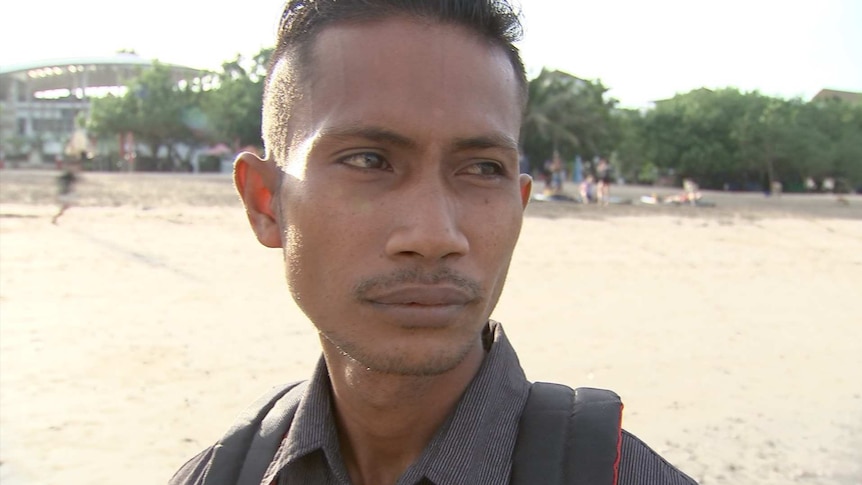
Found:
[614,88,862,190]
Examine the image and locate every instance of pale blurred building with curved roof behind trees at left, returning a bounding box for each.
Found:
[0,53,207,164]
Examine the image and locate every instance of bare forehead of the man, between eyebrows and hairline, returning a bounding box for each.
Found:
[276,17,521,149]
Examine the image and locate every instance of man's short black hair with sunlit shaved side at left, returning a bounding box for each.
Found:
[263,0,527,163]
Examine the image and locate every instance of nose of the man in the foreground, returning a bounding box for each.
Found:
[386,177,470,261]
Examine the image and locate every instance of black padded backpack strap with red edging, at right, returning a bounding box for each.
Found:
[510,382,622,485]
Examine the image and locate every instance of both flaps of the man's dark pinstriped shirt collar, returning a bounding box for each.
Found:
[266,320,529,485]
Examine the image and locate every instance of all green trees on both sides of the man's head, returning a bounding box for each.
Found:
[88,49,862,190]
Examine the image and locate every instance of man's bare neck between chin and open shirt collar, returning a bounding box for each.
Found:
[324,341,485,485]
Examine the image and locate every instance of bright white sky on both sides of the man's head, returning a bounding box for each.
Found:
[0,0,862,107]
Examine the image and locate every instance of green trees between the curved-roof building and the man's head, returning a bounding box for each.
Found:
[85,49,272,170]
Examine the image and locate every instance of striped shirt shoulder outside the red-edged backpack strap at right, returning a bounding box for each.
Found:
[618,430,697,485]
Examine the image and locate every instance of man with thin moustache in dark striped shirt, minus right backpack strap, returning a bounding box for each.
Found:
[172,0,693,485]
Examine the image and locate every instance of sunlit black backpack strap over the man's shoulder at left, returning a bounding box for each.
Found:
[203,382,306,485]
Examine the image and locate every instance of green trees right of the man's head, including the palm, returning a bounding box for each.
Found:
[521,70,862,190]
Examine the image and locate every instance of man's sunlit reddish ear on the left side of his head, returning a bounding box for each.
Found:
[233,152,282,248]
